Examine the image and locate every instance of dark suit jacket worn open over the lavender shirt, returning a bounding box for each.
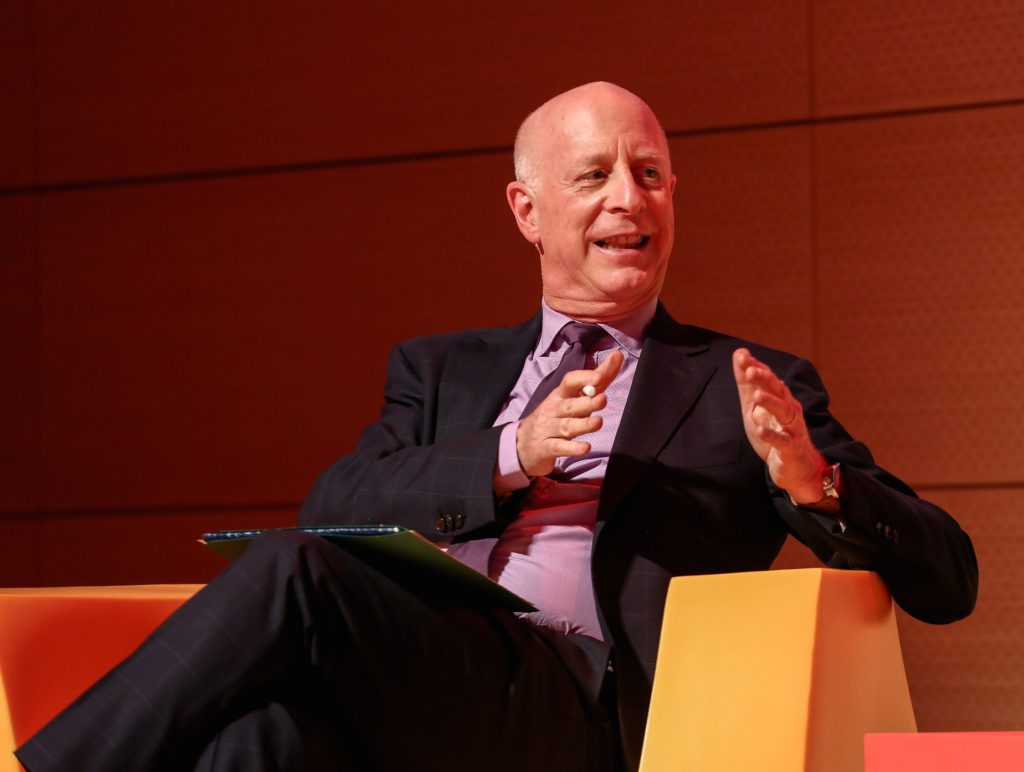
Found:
[300,306,978,768]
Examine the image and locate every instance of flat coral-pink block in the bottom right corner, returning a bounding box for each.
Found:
[864,732,1024,772]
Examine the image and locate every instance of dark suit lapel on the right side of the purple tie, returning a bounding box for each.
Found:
[598,304,718,521]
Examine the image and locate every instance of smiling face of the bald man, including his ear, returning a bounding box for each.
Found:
[509,87,676,320]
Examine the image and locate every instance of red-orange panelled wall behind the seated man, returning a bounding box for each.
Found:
[0,0,1024,729]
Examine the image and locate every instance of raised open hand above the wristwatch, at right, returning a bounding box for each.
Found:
[732,348,827,504]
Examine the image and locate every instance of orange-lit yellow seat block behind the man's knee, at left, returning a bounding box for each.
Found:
[0,585,202,772]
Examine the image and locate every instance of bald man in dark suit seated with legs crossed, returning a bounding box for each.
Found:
[19,83,977,772]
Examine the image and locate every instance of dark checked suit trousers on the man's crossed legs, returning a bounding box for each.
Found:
[17,531,618,772]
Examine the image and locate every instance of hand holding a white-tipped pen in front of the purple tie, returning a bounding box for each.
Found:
[515,349,623,477]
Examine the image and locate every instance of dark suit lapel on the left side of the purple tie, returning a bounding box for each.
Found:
[437,314,541,439]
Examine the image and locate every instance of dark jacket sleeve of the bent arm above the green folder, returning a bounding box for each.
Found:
[299,339,512,539]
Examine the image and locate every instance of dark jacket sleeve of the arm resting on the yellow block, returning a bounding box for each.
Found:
[769,352,978,624]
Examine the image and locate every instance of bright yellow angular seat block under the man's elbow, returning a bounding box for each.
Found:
[640,568,916,772]
